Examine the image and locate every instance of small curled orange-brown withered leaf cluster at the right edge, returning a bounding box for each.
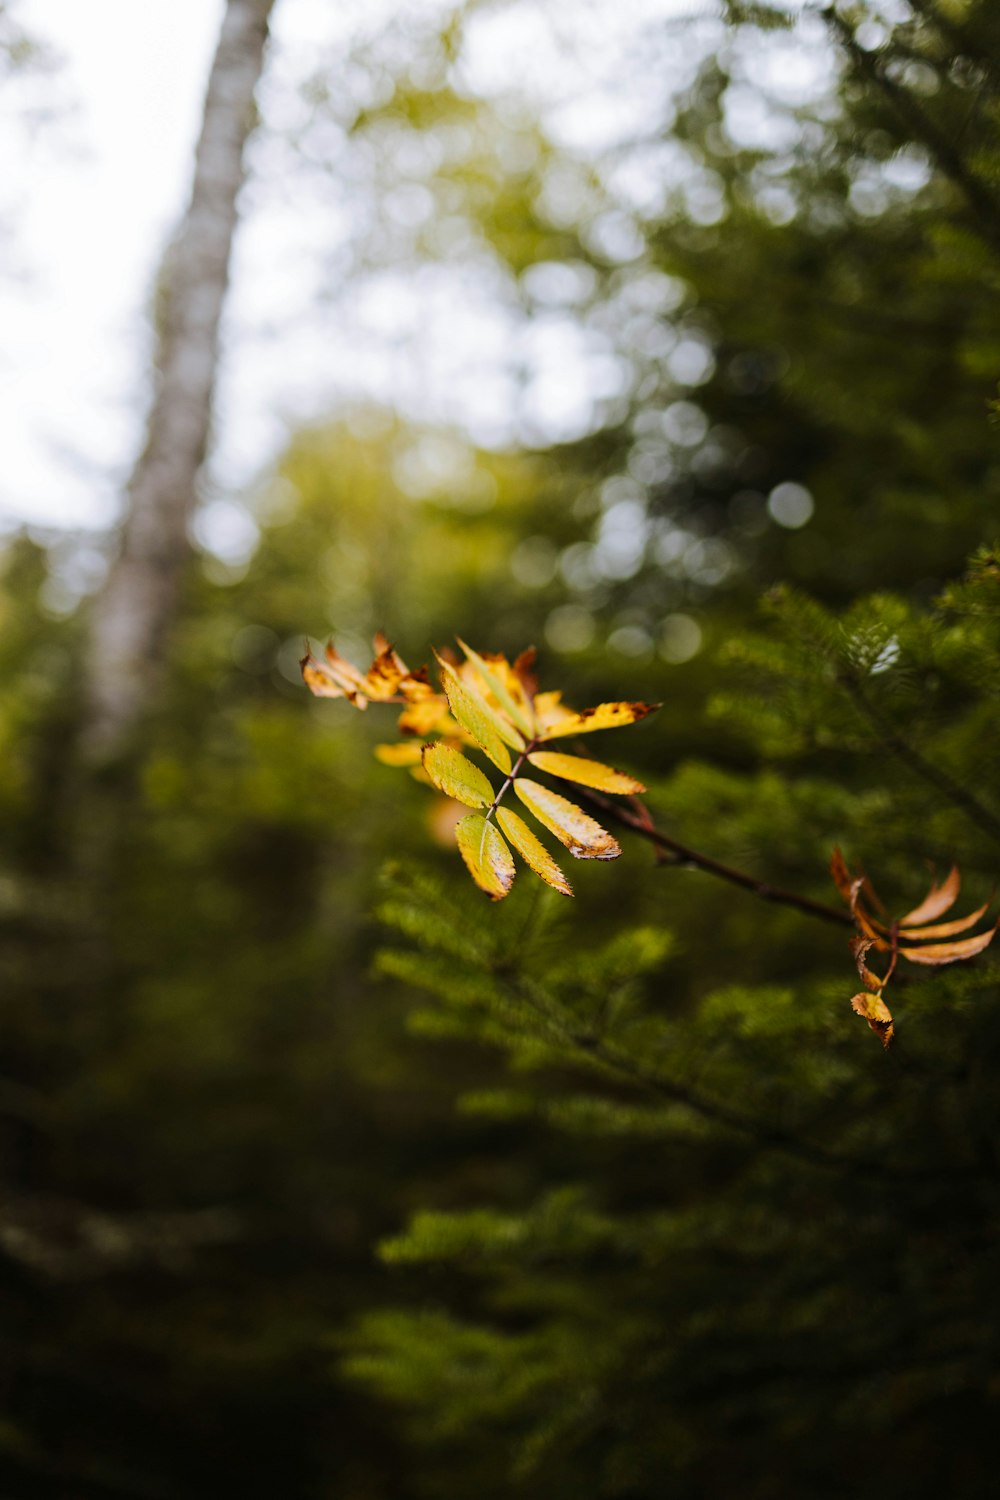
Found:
[831,849,1000,1047]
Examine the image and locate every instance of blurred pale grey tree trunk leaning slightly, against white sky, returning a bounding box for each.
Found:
[84,0,274,759]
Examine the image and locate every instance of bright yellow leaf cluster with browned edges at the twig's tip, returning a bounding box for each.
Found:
[301,635,658,900]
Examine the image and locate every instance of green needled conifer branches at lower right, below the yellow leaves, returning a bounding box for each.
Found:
[348,555,1000,1496]
